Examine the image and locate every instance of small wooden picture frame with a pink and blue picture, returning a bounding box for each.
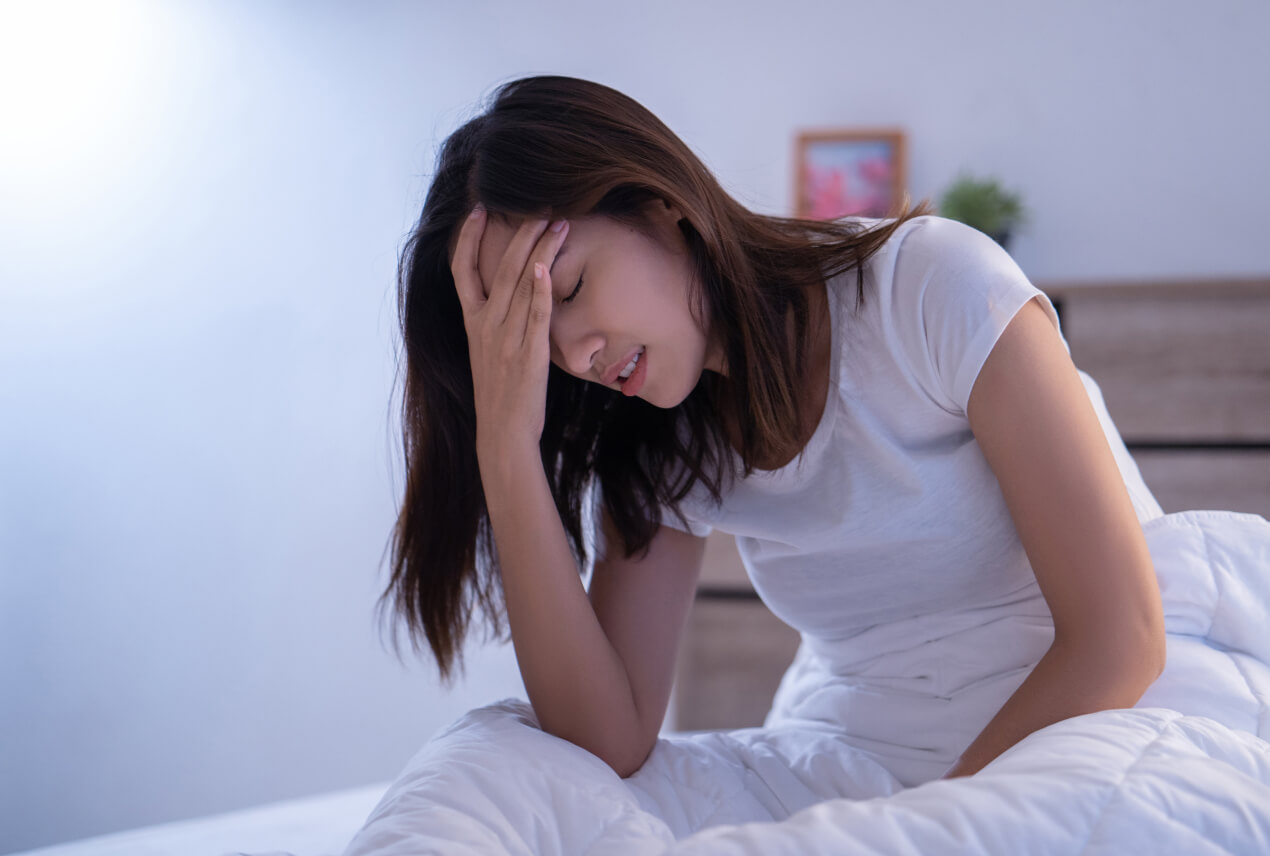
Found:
[794,128,908,220]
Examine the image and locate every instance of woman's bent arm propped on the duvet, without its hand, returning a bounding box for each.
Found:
[480,452,705,776]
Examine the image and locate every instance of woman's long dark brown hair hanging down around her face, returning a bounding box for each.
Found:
[378,76,931,681]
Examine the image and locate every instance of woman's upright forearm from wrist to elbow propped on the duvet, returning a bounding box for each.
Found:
[478,447,648,776]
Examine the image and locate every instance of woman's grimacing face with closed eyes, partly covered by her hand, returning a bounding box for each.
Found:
[476,202,723,408]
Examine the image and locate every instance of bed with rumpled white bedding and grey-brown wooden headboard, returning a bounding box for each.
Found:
[23,281,1270,856]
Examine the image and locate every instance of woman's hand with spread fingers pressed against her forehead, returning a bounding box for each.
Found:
[450,206,569,456]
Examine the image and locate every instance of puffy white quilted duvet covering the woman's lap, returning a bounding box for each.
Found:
[345,511,1270,856]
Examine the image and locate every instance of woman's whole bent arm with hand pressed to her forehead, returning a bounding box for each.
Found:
[451,204,704,776]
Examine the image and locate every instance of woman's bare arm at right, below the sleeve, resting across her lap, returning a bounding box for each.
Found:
[944,298,1165,779]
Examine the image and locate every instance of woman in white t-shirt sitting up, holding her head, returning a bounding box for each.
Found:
[384,76,1165,785]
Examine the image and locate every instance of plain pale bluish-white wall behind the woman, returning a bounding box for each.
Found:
[0,0,1270,852]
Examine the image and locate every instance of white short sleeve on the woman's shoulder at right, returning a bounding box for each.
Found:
[890,215,1071,415]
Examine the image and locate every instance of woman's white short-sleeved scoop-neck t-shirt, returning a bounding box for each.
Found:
[663,216,1163,640]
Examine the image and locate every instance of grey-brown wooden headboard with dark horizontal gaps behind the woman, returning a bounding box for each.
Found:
[668,278,1270,730]
